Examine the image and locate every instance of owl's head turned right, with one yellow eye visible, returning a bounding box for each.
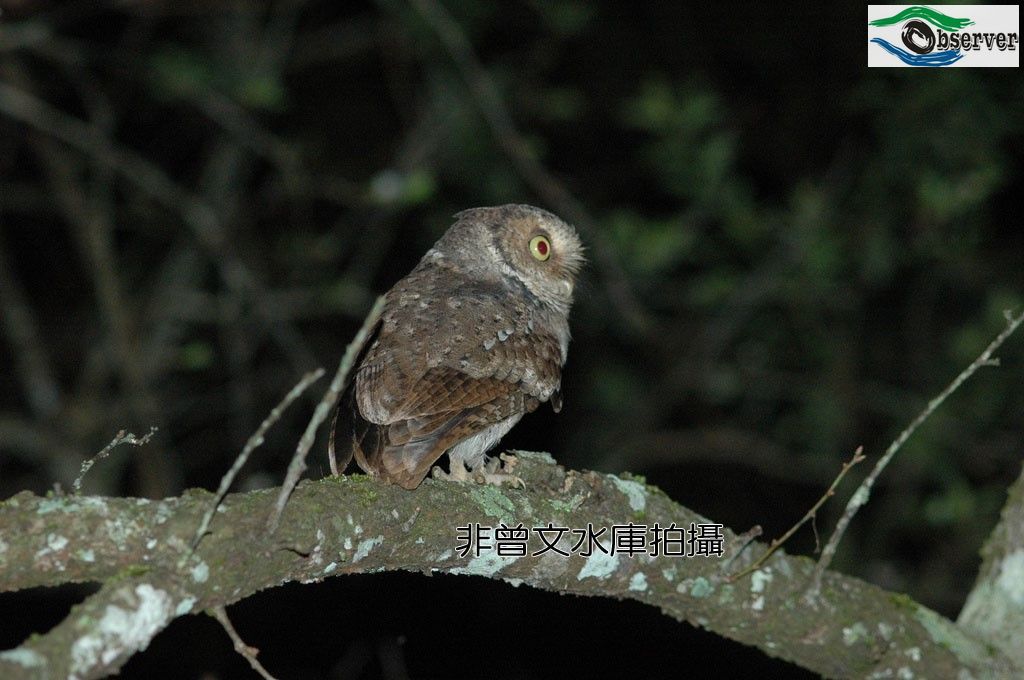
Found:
[456,204,586,313]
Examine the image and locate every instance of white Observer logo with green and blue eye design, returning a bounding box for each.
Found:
[867,5,1020,67]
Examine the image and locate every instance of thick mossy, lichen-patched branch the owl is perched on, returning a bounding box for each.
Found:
[0,453,1020,678]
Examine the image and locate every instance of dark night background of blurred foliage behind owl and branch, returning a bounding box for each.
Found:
[0,0,1024,678]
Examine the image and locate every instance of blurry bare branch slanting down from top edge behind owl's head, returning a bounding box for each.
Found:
[410,0,651,332]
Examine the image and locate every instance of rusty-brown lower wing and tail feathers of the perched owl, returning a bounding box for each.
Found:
[353,367,539,488]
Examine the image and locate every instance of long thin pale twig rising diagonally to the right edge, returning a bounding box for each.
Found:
[806,309,1024,600]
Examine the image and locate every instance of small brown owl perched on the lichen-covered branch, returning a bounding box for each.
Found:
[332,205,585,488]
